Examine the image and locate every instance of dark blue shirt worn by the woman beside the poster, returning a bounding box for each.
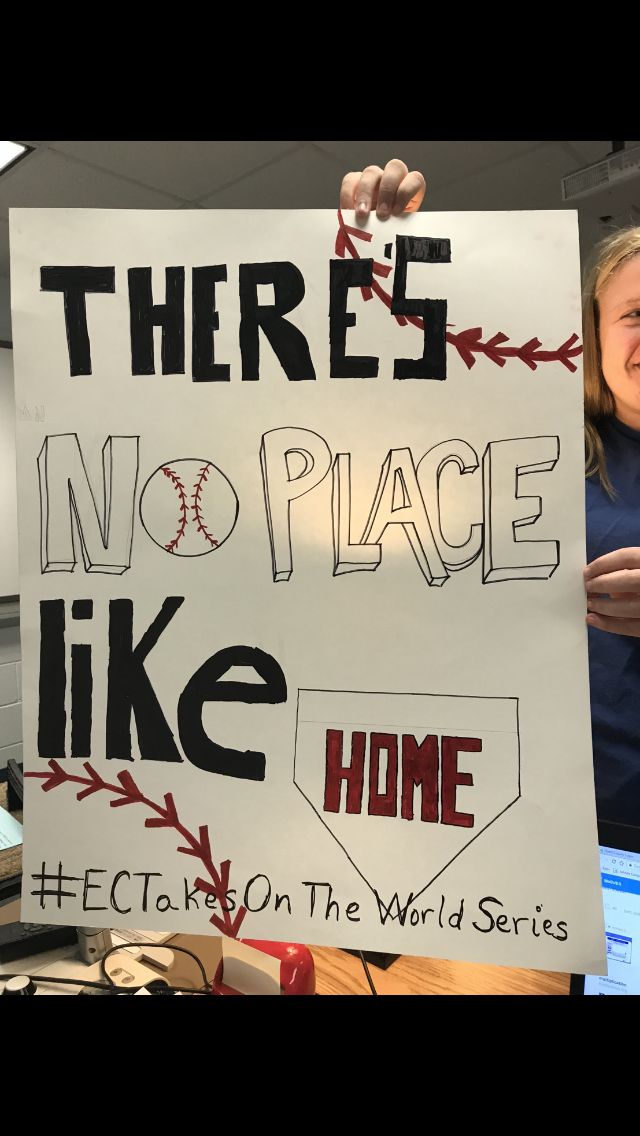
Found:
[587,417,640,825]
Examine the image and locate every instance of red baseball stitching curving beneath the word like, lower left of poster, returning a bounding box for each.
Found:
[25,758,247,938]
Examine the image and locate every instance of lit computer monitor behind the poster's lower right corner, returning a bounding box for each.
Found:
[571,820,640,994]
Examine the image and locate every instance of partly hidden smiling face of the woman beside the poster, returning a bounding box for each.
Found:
[598,253,640,429]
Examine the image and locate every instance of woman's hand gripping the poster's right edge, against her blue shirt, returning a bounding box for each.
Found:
[584,548,640,638]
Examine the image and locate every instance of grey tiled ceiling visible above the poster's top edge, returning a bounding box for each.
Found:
[0,140,640,339]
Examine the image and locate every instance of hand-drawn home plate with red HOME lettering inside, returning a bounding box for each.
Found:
[294,690,520,908]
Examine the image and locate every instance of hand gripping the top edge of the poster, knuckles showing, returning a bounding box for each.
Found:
[340,158,426,222]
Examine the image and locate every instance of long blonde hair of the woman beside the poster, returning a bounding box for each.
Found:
[582,227,640,498]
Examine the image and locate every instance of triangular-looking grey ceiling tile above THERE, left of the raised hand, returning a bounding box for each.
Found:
[51,141,301,201]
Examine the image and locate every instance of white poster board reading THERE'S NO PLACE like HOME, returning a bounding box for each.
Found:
[11,210,604,972]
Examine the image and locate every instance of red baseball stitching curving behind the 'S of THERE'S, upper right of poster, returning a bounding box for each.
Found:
[335,209,582,371]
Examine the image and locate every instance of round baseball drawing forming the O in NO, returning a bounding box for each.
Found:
[140,458,239,557]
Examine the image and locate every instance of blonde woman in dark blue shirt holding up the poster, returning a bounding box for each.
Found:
[340,158,640,825]
